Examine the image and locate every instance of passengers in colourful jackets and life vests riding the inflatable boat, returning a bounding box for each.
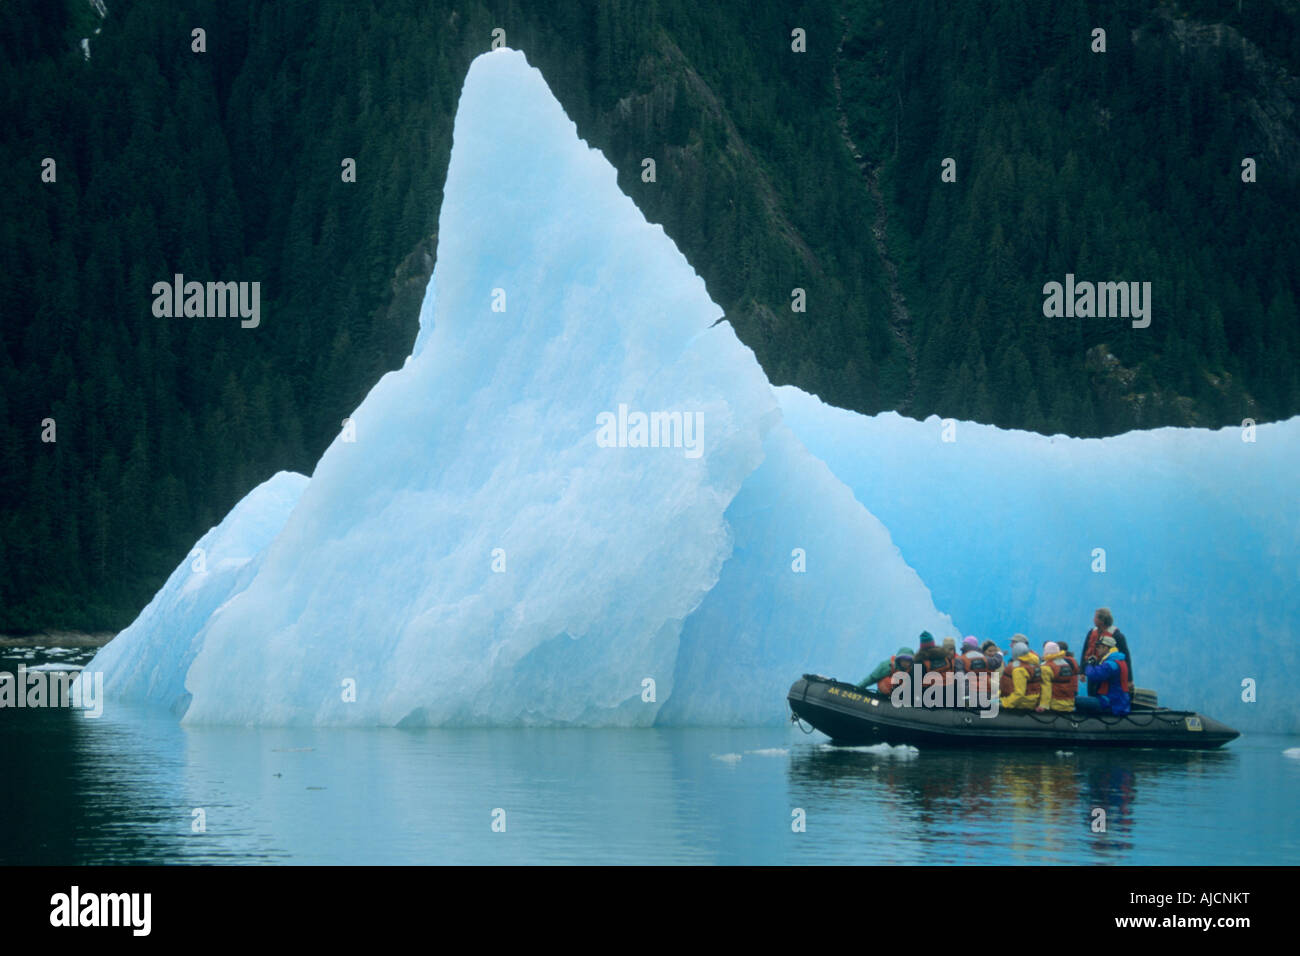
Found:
[858,607,1134,715]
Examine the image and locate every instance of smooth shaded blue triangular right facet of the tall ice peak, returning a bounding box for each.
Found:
[659,424,956,724]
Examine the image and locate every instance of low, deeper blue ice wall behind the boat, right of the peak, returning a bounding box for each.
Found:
[776,388,1300,731]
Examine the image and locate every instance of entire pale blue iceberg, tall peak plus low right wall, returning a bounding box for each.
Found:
[88,49,1296,727]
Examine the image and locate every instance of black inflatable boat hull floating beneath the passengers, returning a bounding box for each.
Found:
[789,674,1240,750]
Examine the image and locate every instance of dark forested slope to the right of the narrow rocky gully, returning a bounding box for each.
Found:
[841,0,1300,436]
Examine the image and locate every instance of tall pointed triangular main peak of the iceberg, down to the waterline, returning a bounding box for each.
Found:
[170,51,941,724]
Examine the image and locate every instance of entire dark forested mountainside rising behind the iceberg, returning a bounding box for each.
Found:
[0,0,1300,630]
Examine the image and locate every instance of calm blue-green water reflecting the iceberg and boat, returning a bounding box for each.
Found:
[0,649,1300,865]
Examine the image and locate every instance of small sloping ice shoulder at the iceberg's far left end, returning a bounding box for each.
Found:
[86,471,307,711]
